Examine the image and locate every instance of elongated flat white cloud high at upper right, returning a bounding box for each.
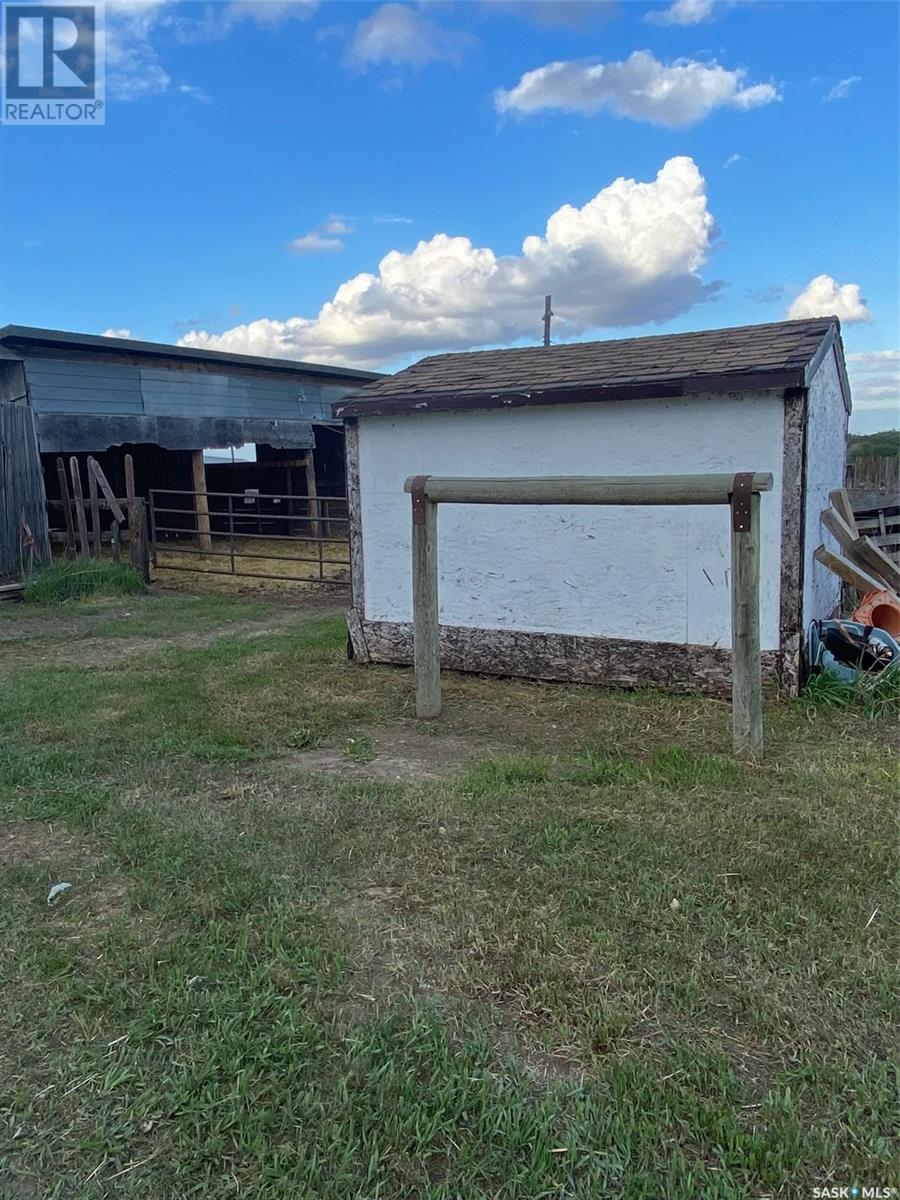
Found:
[494,50,781,130]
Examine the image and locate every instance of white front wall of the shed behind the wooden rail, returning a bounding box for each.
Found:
[359,392,784,650]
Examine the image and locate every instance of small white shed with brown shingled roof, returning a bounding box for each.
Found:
[335,318,851,692]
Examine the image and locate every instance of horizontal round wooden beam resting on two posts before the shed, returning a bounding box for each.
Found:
[403,472,772,504]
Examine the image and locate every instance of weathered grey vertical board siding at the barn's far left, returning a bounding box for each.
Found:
[0,401,50,578]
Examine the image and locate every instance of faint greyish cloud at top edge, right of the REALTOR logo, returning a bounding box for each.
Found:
[347,4,474,70]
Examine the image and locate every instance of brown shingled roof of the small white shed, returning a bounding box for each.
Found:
[334,317,850,416]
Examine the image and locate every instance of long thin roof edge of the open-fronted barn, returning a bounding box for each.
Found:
[0,325,382,383]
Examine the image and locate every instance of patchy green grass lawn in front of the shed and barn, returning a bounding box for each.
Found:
[0,595,900,1200]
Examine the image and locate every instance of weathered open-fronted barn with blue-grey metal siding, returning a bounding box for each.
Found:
[0,325,379,576]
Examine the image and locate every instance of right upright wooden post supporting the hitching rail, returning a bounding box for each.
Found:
[731,476,762,758]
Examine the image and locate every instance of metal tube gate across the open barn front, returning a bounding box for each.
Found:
[150,487,350,587]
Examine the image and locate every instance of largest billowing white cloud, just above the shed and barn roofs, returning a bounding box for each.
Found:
[182,157,716,366]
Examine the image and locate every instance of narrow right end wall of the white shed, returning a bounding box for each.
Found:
[803,349,847,630]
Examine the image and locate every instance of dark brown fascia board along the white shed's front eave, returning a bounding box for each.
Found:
[331,367,806,419]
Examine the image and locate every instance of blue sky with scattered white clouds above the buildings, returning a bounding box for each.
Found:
[0,0,900,432]
